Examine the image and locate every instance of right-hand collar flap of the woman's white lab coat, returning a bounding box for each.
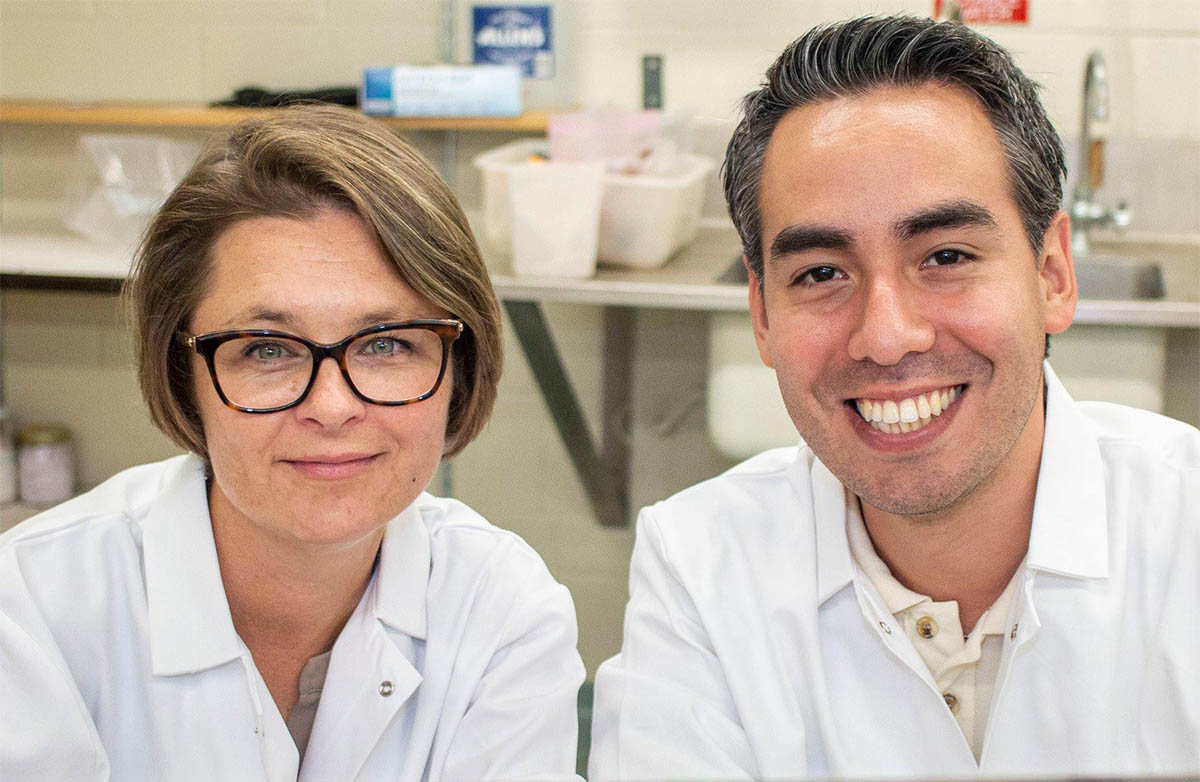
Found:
[371,495,430,640]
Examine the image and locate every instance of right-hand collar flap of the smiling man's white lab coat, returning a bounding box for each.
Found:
[1027,363,1109,578]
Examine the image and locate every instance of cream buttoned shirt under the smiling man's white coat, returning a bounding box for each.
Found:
[846,492,1021,762]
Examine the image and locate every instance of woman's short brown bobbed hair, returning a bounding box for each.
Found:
[125,106,502,458]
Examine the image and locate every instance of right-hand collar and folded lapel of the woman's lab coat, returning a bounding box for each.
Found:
[300,504,430,781]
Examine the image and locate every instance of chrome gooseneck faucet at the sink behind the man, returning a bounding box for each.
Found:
[1070,52,1130,257]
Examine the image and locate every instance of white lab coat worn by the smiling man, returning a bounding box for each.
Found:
[590,367,1200,780]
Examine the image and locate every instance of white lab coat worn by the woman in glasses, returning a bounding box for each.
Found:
[0,456,583,782]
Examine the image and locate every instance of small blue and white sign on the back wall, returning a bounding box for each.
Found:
[472,5,554,79]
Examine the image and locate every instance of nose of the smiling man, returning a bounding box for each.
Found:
[847,279,936,366]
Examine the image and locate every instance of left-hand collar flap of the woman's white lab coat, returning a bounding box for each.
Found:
[143,453,241,676]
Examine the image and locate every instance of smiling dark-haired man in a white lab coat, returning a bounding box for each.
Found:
[592,18,1200,780]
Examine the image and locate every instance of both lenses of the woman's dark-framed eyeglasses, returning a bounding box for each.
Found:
[212,329,443,408]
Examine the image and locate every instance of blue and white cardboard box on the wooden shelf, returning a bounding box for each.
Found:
[359,65,521,116]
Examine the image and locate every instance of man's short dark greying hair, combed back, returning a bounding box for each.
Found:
[722,17,1067,282]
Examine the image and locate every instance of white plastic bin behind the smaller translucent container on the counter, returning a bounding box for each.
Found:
[474,139,715,269]
